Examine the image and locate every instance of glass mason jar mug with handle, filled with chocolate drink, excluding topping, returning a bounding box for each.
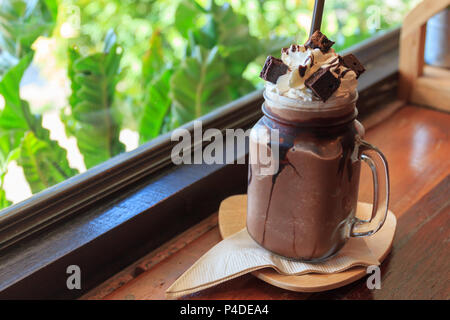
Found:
[247,92,389,261]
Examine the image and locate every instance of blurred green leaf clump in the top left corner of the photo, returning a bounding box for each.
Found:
[0,0,58,78]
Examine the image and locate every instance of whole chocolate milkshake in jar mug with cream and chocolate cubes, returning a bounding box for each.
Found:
[247,31,388,261]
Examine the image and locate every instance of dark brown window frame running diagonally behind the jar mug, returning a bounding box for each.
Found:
[0,28,400,298]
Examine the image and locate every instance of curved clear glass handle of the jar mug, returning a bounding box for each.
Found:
[350,140,389,237]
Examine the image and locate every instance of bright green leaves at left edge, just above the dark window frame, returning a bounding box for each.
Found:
[0,54,77,200]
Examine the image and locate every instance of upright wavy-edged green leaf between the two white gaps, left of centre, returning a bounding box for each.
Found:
[65,32,125,168]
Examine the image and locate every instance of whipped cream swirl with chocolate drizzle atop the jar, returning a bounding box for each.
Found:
[265,44,358,101]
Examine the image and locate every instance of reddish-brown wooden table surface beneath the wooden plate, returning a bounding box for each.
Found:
[82,105,450,299]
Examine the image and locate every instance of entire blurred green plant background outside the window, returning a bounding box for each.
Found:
[0,0,419,208]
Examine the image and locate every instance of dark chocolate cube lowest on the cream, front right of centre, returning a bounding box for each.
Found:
[305,68,341,102]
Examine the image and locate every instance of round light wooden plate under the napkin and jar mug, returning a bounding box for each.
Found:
[219,194,397,292]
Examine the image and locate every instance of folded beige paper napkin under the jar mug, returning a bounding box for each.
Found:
[166,228,380,299]
